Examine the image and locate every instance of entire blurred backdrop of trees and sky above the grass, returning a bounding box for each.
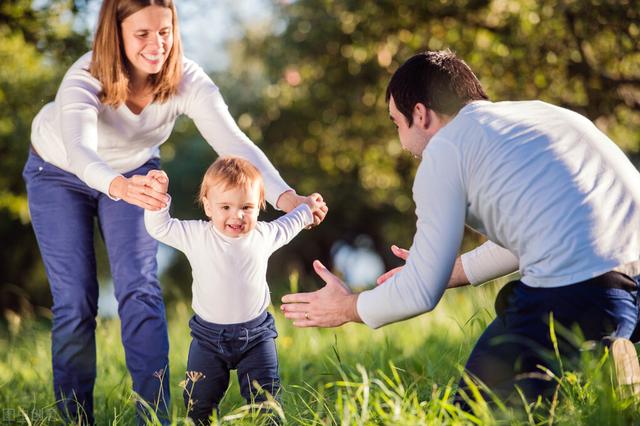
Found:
[0,0,640,316]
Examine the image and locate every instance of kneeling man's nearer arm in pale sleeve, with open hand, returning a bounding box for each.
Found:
[282,140,466,328]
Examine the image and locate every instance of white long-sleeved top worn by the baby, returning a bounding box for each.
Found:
[144,203,313,324]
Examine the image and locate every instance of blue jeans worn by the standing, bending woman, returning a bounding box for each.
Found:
[23,151,169,423]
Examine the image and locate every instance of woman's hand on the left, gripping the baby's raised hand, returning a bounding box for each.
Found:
[109,175,169,210]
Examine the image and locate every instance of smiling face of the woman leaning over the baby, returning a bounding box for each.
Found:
[121,6,173,83]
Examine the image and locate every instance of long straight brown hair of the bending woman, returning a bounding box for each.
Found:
[89,0,182,107]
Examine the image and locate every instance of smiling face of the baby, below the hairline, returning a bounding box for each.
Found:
[203,182,260,238]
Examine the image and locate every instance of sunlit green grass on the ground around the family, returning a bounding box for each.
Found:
[0,284,640,426]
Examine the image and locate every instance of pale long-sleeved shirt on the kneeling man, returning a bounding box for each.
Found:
[357,101,640,327]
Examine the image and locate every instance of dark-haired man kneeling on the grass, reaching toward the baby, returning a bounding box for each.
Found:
[282,51,640,397]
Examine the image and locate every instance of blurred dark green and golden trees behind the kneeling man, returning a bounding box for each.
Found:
[168,0,640,290]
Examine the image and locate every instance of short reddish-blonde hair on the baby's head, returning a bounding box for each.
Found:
[198,157,266,209]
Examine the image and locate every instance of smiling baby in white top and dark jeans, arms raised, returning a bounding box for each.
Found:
[144,157,325,424]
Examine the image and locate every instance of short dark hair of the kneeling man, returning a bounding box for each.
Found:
[386,49,489,126]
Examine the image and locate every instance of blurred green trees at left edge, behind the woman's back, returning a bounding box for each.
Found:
[0,0,88,310]
